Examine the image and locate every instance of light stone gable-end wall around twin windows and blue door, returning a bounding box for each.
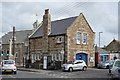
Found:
[67,14,95,67]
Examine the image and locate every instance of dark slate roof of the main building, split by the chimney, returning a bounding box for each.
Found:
[29,16,77,38]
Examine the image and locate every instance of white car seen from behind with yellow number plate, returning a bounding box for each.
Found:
[1,60,17,74]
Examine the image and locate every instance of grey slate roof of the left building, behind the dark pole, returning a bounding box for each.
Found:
[2,30,32,44]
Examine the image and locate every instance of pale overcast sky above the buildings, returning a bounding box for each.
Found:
[0,2,118,46]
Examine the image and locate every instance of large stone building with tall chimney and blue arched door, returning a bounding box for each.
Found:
[29,9,95,67]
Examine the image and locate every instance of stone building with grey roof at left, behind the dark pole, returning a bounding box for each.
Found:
[2,30,32,66]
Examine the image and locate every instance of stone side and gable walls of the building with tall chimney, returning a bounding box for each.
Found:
[30,14,95,67]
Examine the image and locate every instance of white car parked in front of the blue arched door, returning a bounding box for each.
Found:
[61,60,87,72]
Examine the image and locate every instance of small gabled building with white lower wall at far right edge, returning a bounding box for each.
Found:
[105,39,120,59]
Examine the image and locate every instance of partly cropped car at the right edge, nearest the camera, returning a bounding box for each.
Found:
[109,59,120,79]
